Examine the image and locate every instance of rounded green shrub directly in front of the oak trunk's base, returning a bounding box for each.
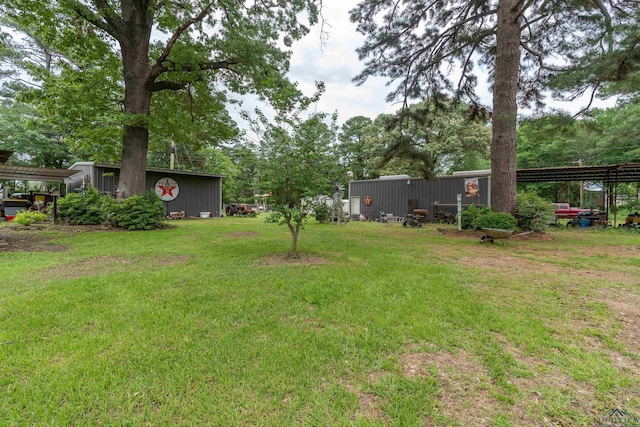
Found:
[108,191,166,231]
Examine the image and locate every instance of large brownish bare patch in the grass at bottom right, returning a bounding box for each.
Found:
[399,342,596,426]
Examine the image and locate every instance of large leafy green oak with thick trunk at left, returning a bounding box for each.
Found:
[0,0,320,195]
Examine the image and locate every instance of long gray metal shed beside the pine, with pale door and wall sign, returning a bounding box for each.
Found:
[349,171,491,221]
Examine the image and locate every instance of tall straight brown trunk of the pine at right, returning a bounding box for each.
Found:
[491,0,522,213]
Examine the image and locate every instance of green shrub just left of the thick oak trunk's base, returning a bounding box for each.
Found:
[58,187,114,225]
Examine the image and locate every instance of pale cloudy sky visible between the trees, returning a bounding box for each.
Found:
[234,0,613,129]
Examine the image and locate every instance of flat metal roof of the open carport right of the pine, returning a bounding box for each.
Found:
[516,163,640,182]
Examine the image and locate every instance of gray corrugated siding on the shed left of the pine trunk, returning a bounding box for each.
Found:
[349,176,489,221]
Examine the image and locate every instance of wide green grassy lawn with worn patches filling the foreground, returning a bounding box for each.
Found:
[0,218,640,426]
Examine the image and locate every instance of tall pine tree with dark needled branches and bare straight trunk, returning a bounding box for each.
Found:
[351,0,637,212]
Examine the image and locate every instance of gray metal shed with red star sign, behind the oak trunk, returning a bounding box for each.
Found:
[65,162,224,217]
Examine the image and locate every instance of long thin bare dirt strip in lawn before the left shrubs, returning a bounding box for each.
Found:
[47,255,189,279]
